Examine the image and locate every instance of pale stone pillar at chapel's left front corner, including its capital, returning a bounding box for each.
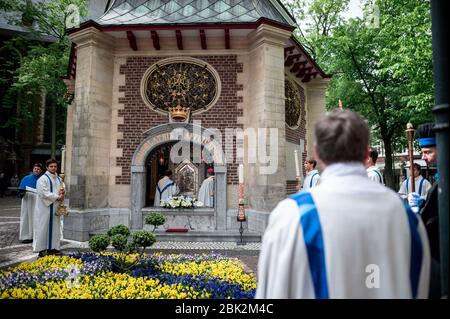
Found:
[66,27,114,210]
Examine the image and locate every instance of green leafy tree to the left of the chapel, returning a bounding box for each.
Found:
[0,0,87,155]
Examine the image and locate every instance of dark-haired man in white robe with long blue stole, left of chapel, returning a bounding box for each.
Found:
[33,159,64,257]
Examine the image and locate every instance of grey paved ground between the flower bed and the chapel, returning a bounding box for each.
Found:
[0,196,261,274]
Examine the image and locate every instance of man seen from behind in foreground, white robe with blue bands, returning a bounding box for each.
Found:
[256,110,430,299]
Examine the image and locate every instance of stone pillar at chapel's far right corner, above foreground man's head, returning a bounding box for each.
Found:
[306,79,329,164]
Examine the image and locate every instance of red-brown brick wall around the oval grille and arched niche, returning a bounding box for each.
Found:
[116,55,243,184]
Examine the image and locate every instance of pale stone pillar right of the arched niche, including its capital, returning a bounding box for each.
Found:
[244,24,291,214]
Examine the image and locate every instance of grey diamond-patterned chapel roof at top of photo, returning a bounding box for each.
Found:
[93,0,295,26]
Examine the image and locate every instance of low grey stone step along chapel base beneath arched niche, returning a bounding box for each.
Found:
[89,229,261,243]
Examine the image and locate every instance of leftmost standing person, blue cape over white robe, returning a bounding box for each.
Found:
[18,163,42,244]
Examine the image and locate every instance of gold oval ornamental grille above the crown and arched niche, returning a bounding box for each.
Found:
[141,60,219,113]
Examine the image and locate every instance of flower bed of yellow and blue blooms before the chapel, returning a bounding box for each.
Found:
[0,253,256,299]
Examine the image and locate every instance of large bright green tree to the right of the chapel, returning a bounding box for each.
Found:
[286,0,433,188]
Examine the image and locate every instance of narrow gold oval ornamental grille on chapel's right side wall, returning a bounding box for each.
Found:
[284,78,305,129]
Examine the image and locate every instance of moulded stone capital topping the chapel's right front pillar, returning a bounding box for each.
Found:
[247,24,292,50]
